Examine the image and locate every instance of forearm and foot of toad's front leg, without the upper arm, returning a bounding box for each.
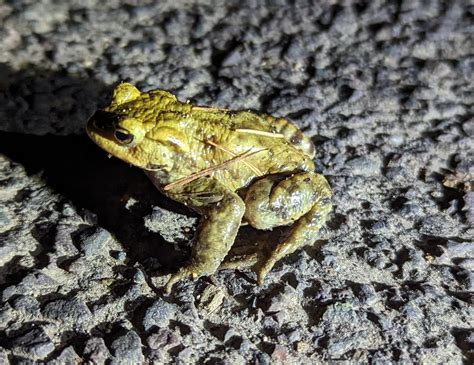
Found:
[166,182,245,292]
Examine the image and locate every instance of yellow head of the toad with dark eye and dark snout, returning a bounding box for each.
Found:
[86,83,188,171]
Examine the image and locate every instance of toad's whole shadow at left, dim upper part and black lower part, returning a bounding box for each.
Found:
[0,64,192,271]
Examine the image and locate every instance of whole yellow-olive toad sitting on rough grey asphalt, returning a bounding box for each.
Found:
[86,83,332,292]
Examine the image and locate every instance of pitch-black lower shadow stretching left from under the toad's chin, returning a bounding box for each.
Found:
[0,132,196,270]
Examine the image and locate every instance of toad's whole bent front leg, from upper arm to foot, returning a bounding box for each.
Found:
[162,178,245,293]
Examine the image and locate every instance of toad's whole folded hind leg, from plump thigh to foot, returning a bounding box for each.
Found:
[245,172,332,284]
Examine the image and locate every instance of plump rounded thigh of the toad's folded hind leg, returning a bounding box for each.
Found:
[245,172,320,230]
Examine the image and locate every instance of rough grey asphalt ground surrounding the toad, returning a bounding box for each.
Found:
[0,0,474,364]
